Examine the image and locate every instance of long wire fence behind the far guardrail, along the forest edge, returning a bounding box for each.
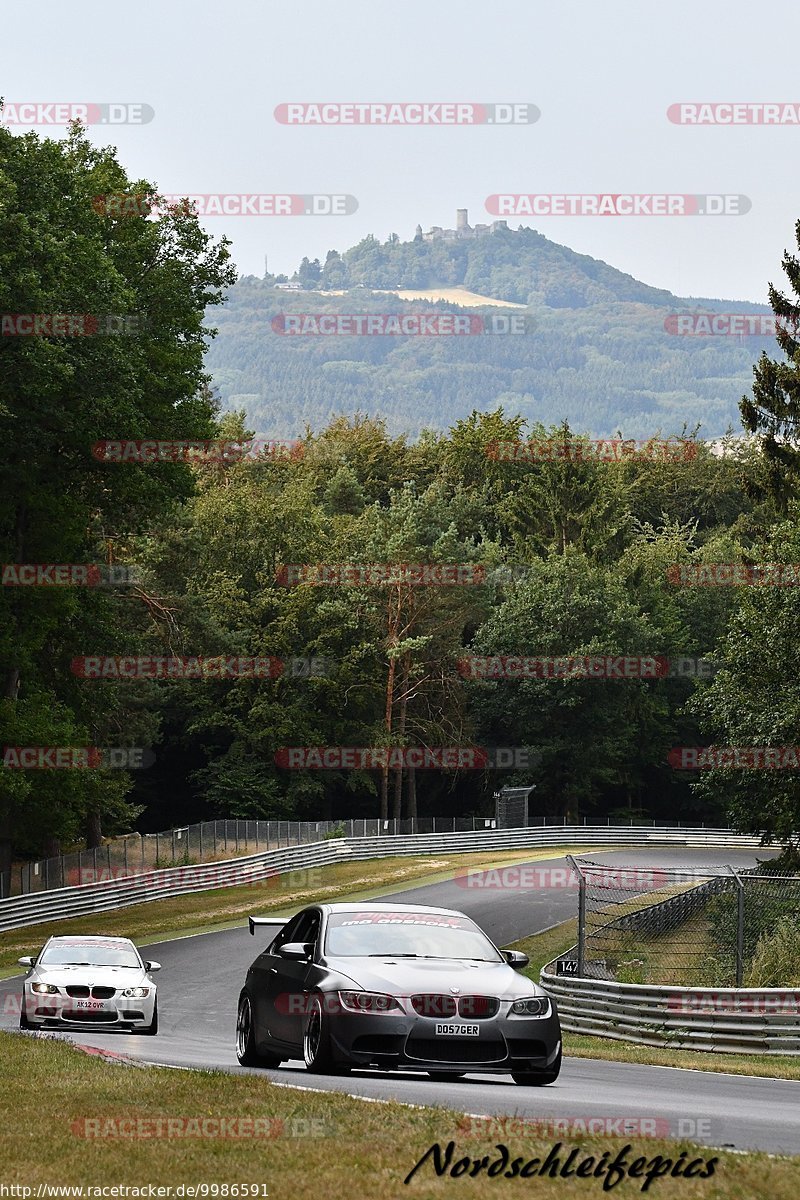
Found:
[7,816,714,899]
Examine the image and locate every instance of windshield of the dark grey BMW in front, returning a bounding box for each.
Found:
[325,912,504,962]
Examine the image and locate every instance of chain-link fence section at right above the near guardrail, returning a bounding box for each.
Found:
[561,859,800,988]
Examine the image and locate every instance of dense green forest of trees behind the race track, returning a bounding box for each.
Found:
[0,128,800,892]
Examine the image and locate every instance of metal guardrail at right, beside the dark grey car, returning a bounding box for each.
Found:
[541,969,800,1055]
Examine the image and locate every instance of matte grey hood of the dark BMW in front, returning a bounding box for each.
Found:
[327,954,543,1000]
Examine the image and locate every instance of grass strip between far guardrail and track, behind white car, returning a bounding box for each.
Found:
[0,847,599,978]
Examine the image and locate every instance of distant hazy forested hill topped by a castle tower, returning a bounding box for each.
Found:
[207,228,780,438]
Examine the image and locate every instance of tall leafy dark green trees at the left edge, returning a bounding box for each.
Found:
[0,125,235,878]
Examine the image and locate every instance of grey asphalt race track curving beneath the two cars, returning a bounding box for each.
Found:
[0,848,800,1154]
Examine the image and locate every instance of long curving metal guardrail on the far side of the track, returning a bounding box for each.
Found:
[0,826,760,932]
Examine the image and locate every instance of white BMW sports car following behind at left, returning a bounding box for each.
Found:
[19,935,161,1034]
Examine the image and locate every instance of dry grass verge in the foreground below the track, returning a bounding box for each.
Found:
[0,1033,800,1200]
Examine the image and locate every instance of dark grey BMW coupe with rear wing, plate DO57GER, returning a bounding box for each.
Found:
[236,904,561,1085]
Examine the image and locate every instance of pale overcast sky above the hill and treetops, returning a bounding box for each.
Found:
[0,0,800,301]
